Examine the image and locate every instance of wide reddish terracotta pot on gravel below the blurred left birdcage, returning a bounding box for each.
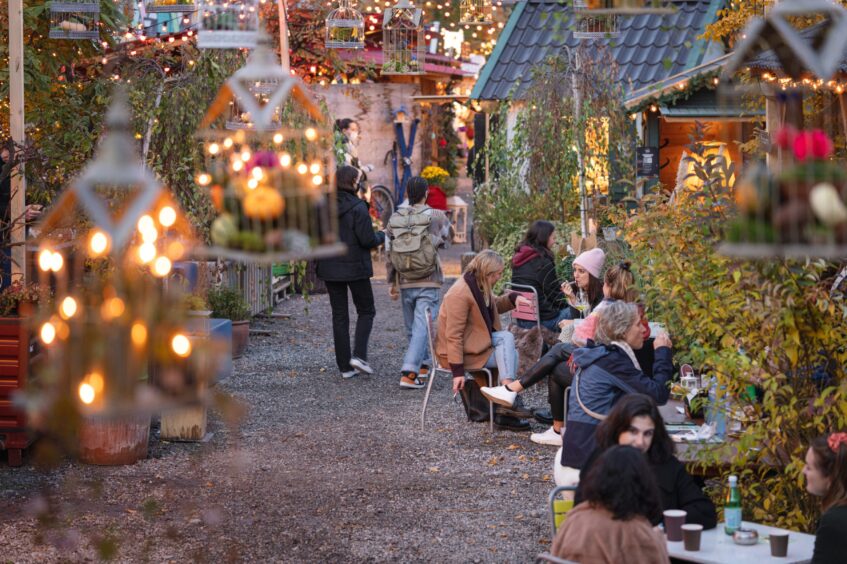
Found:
[79,415,150,466]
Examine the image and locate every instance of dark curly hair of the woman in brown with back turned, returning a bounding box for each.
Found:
[581,445,662,523]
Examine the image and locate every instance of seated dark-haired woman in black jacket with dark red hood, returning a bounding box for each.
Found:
[512,219,571,332]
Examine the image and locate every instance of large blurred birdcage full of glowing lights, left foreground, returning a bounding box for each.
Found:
[36,91,212,428]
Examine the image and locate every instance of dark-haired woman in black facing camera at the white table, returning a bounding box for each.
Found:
[574,394,718,529]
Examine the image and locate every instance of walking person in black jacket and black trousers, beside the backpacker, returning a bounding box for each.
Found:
[317,166,385,378]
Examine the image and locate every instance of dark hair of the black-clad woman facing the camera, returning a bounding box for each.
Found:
[594,394,673,464]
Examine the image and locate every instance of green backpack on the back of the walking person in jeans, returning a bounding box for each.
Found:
[388,207,438,280]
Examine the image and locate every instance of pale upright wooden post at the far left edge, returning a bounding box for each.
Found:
[9,0,26,282]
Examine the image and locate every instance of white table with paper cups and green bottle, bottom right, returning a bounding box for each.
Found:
[667,521,815,564]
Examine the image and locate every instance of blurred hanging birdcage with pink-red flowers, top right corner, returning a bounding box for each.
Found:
[719,0,847,259]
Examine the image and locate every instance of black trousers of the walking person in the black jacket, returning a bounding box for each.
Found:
[326,278,376,372]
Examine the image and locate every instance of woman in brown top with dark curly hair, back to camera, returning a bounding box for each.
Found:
[551,445,670,564]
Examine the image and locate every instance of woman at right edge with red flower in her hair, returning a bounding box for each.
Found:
[803,433,847,564]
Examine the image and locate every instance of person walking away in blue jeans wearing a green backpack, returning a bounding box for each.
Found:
[385,176,450,389]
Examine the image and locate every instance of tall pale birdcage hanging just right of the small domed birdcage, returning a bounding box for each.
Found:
[382,0,426,74]
